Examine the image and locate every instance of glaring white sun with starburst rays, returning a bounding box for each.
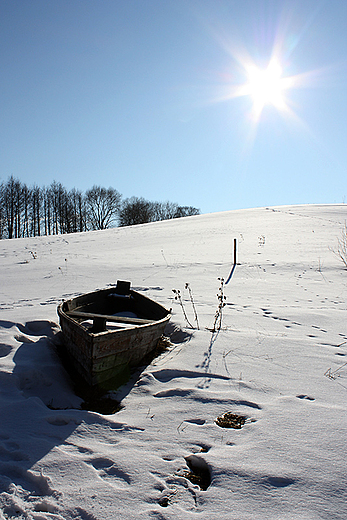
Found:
[205,11,324,130]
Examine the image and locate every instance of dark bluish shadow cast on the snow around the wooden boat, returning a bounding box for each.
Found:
[0,320,191,497]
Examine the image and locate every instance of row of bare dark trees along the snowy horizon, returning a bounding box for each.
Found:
[0,176,200,238]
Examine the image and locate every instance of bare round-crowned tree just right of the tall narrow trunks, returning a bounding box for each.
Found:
[85,186,121,229]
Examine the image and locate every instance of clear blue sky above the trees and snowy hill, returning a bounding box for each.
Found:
[0,0,347,213]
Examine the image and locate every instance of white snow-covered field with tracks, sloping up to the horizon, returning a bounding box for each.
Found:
[0,204,347,520]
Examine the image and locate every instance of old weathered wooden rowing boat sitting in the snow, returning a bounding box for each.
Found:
[57,281,171,389]
